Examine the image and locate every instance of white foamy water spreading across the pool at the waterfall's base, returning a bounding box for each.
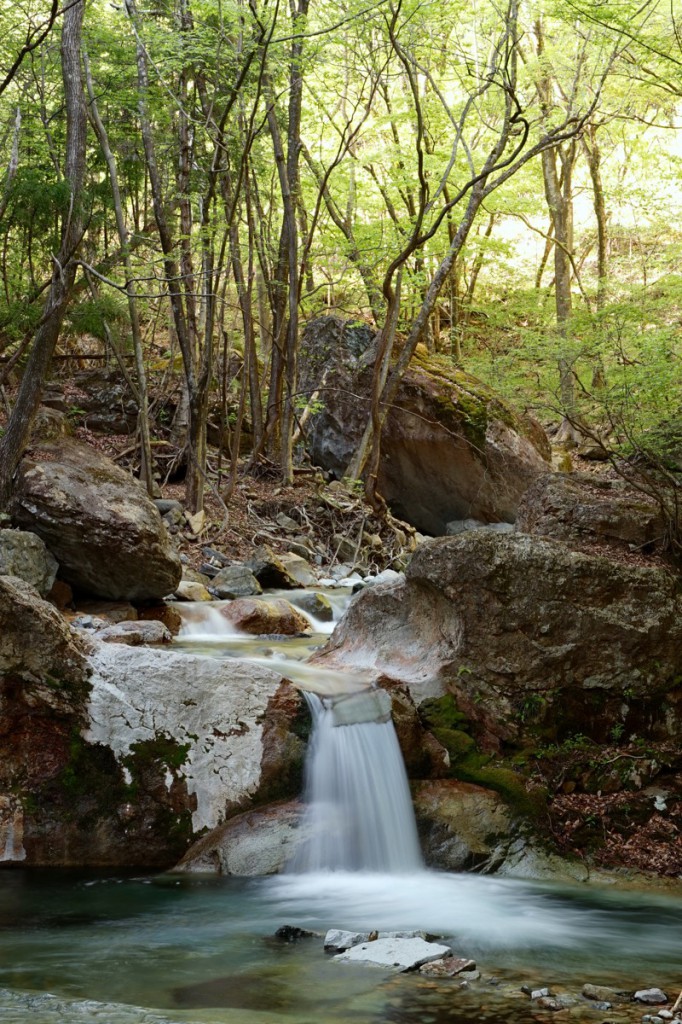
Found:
[267,870,681,961]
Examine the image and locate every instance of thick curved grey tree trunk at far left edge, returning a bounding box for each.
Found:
[0,0,87,507]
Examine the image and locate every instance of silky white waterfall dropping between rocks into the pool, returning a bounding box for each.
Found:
[289,690,423,872]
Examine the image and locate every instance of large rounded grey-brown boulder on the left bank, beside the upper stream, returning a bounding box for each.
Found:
[10,437,182,601]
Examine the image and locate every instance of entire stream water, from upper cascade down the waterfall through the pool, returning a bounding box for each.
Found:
[5,593,682,1024]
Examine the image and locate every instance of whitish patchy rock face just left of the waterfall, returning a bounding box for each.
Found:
[84,641,282,831]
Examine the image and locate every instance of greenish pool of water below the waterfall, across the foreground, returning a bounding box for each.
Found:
[0,869,682,1024]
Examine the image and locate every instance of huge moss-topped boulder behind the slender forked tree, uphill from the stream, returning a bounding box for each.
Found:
[301,315,550,535]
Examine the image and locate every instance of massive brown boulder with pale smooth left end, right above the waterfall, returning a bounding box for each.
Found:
[317,530,682,750]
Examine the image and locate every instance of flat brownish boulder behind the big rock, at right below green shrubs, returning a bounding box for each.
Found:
[516,473,667,553]
